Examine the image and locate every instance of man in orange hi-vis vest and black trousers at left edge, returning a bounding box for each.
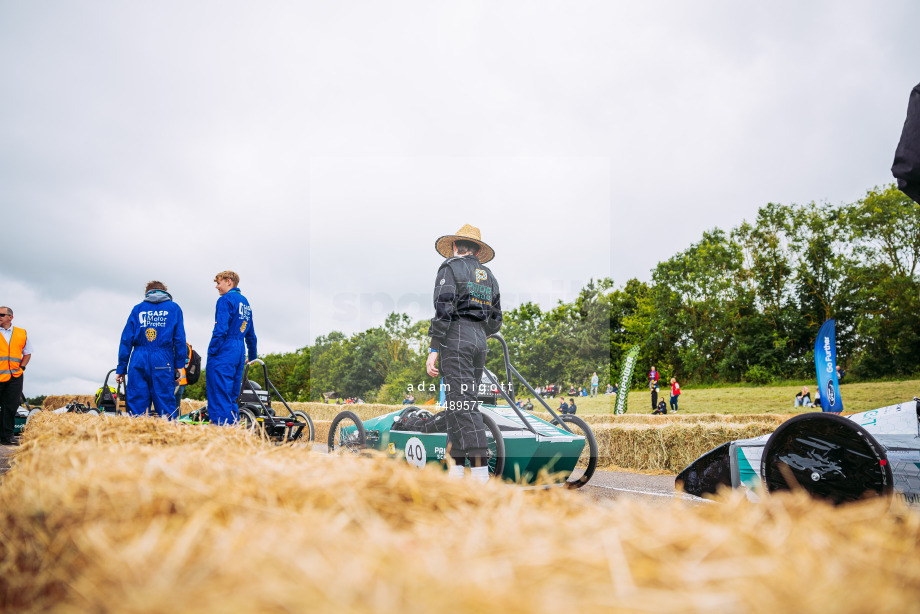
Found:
[0,307,32,446]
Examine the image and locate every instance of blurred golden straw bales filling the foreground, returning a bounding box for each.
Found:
[0,416,920,614]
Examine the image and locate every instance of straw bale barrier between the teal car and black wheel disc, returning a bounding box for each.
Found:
[592,422,776,473]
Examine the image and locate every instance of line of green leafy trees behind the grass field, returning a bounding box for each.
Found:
[187,185,920,402]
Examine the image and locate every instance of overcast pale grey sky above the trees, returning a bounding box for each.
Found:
[0,0,920,396]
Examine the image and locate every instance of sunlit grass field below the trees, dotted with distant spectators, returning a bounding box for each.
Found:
[500,380,920,414]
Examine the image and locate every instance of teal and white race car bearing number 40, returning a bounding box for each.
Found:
[327,335,598,488]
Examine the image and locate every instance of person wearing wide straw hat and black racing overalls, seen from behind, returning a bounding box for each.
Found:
[425,224,502,482]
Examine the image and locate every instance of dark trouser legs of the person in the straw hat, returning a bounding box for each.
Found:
[439,320,489,459]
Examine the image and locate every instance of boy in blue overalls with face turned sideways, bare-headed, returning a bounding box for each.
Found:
[205,271,258,424]
